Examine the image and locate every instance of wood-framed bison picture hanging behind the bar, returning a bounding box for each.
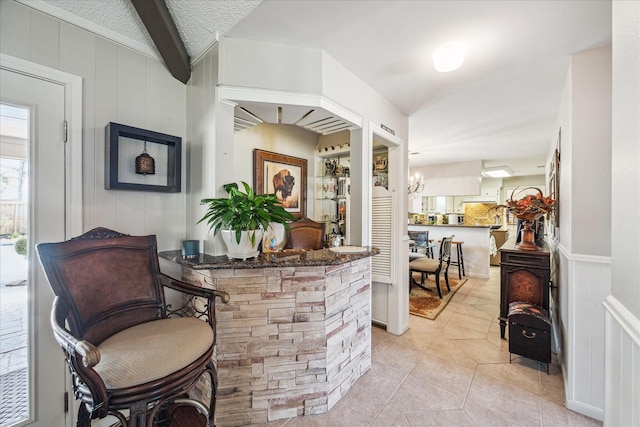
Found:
[253,149,307,219]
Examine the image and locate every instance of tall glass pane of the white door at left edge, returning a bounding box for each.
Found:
[0,104,31,427]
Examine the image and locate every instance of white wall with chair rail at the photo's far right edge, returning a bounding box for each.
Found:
[604,1,640,426]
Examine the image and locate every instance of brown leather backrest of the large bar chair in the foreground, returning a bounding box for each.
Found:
[37,228,165,345]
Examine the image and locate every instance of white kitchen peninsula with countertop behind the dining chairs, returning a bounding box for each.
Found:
[408,224,492,278]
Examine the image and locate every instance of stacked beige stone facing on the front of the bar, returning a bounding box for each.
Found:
[183,258,371,427]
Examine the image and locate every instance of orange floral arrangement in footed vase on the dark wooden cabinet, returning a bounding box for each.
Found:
[492,187,556,251]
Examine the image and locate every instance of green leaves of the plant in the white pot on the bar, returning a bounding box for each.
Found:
[198,182,295,244]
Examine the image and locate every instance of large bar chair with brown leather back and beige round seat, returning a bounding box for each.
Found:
[36,228,229,427]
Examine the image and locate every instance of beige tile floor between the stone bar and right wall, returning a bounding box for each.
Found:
[266,267,602,427]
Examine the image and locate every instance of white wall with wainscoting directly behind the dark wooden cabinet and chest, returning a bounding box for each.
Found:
[548,42,612,420]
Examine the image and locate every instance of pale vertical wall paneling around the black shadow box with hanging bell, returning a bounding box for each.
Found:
[0,0,186,249]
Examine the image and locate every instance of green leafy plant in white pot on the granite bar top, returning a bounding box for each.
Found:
[198,182,295,259]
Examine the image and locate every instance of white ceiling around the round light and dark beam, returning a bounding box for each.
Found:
[26,0,611,175]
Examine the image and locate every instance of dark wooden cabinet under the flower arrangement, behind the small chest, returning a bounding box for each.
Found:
[499,244,551,338]
